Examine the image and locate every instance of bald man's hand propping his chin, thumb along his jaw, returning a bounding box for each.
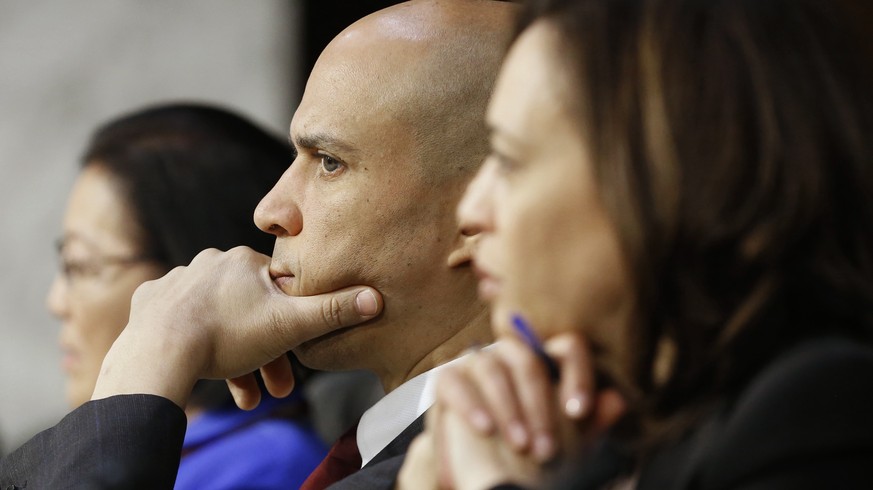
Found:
[92,247,382,408]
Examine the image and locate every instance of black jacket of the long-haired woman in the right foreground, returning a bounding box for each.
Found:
[558,338,873,490]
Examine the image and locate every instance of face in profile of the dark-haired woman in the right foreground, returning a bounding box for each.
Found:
[459,22,631,352]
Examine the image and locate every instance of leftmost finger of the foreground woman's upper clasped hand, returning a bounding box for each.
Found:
[436,366,496,435]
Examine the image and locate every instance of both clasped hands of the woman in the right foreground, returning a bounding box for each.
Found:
[398,333,625,490]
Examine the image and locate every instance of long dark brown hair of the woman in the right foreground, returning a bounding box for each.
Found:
[519,0,873,439]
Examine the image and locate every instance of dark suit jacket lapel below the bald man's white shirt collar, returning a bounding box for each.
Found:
[328,412,426,490]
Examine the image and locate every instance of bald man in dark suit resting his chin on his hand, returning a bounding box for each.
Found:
[0,0,514,488]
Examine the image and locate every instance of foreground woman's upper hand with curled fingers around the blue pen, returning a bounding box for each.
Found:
[437,332,625,462]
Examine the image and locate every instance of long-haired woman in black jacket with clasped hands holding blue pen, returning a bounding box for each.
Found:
[401,0,873,490]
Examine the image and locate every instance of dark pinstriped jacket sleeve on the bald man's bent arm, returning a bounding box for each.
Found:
[0,395,186,490]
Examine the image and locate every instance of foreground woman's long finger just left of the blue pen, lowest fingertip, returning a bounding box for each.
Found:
[497,338,557,461]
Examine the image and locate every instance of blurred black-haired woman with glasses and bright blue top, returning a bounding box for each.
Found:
[47,104,326,489]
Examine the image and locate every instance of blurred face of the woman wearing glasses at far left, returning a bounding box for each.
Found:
[46,165,165,407]
